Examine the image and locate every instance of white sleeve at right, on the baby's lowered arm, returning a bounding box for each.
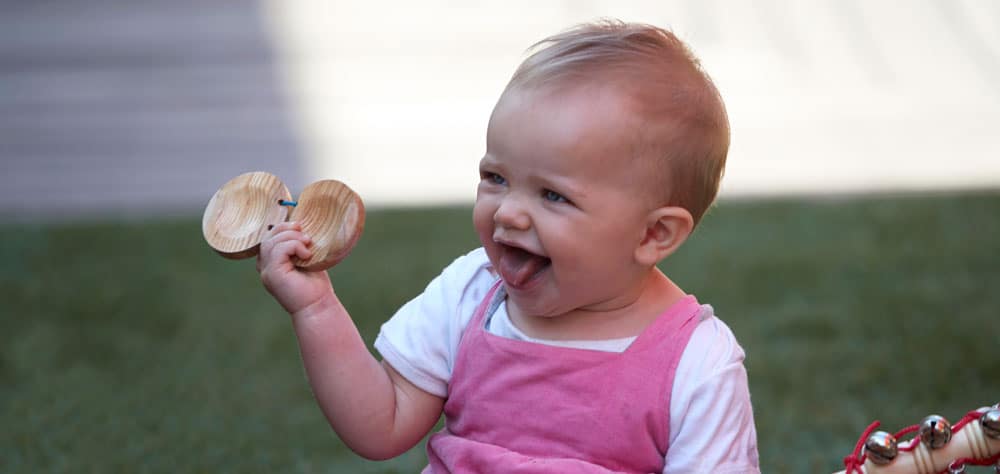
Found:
[663,312,760,473]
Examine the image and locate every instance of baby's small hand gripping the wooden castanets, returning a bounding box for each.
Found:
[257,222,333,315]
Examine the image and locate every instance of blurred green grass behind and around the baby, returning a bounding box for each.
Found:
[0,192,1000,473]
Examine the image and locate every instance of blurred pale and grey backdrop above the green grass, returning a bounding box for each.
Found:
[0,0,1000,215]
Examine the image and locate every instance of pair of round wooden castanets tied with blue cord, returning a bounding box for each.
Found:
[201,171,365,271]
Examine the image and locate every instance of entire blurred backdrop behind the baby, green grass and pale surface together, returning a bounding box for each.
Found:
[0,0,1000,472]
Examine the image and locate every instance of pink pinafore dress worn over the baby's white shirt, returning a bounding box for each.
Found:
[424,282,701,473]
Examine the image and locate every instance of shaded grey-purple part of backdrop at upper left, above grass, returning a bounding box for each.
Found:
[0,0,303,218]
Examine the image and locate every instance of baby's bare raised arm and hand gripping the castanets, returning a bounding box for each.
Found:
[257,222,444,459]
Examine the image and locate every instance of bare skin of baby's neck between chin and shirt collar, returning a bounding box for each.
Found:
[507,269,685,341]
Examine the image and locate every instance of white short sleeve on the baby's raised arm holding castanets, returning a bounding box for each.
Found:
[375,248,496,397]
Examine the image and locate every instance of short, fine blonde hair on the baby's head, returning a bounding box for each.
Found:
[504,20,729,225]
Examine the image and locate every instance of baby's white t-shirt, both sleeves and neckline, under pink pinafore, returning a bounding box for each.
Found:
[375,248,760,473]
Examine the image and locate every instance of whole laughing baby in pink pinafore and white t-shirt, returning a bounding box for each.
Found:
[258,21,759,473]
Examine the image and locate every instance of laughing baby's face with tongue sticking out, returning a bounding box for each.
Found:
[473,87,652,316]
